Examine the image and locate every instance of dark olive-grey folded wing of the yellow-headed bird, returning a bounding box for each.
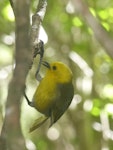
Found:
[50,83,74,126]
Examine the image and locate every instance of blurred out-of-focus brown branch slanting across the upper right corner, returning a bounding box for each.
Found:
[71,0,113,59]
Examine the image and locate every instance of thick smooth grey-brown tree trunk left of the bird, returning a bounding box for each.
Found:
[0,0,32,150]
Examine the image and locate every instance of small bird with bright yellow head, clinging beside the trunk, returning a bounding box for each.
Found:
[25,62,74,131]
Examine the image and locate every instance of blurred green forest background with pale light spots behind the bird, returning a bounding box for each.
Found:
[0,0,113,150]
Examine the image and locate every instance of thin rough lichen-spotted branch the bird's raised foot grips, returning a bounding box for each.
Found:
[30,0,47,79]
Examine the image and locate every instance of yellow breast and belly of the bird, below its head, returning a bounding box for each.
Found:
[33,80,59,116]
